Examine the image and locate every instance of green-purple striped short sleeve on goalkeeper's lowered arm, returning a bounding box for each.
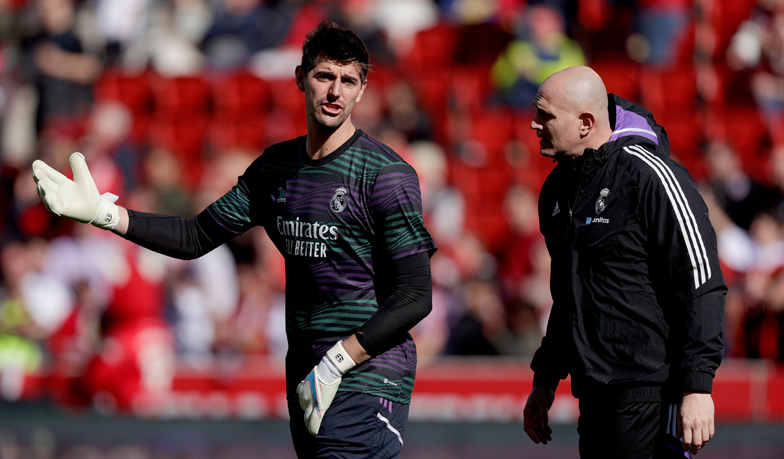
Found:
[369,163,437,260]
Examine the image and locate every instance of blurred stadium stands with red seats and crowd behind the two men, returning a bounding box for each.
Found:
[0,0,784,459]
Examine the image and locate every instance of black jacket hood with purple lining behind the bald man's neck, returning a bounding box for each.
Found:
[603,93,670,158]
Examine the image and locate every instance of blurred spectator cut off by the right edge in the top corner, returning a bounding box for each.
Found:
[727,0,784,144]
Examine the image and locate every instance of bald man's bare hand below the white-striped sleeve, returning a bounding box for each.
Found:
[678,392,716,454]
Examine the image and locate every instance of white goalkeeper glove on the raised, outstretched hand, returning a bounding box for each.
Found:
[33,153,120,230]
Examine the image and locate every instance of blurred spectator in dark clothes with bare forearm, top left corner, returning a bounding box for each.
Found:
[21,0,102,131]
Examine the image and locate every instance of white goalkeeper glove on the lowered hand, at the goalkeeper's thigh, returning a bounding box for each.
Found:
[297,341,357,435]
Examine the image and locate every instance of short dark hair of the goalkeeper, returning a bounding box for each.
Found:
[301,21,370,81]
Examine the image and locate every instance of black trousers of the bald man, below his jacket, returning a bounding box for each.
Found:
[577,401,691,459]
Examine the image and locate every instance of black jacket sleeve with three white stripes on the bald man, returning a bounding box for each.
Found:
[639,150,727,392]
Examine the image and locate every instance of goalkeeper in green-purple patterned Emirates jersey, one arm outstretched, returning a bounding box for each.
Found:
[33,22,436,458]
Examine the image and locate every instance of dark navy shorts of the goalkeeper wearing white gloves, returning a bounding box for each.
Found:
[289,392,409,459]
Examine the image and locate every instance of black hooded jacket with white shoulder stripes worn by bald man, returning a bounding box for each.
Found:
[531,94,727,399]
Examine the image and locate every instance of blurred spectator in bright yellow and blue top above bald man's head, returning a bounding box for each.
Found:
[492,5,585,109]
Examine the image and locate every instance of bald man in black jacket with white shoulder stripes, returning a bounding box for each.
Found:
[524,67,727,459]
